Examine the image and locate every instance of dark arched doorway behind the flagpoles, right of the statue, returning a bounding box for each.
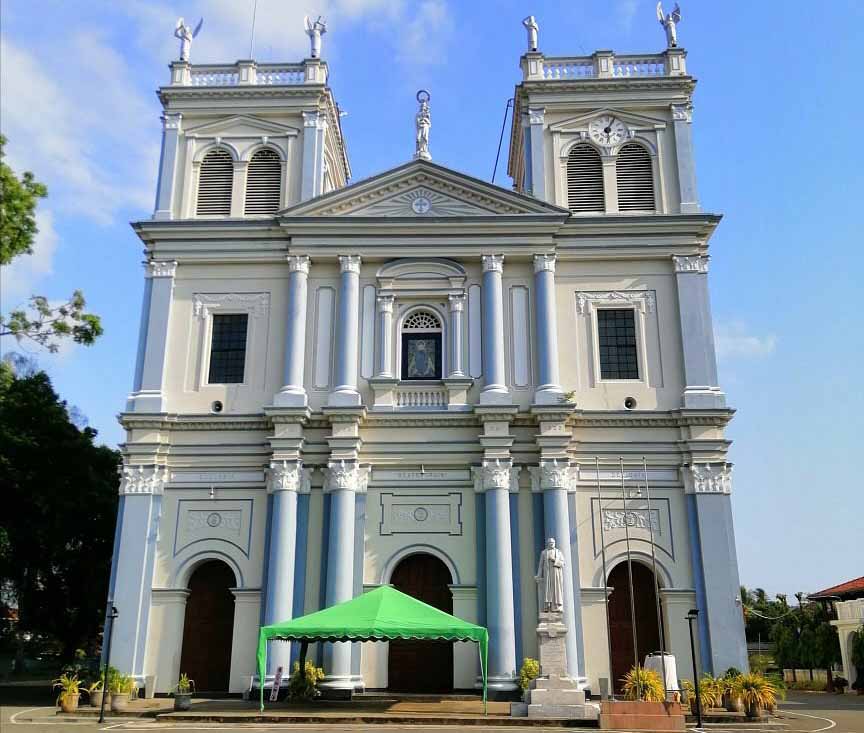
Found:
[608,561,660,690]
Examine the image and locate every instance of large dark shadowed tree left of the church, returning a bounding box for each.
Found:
[0,362,120,658]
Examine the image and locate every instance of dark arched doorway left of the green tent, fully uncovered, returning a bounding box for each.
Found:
[180,560,237,692]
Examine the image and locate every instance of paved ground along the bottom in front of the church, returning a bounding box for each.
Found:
[0,693,864,733]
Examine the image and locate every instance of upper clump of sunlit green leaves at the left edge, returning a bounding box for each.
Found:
[0,135,48,265]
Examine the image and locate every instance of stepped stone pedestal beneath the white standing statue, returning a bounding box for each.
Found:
[510,613,600,720]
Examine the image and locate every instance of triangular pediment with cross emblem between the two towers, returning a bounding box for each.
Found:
[281,160,569,218]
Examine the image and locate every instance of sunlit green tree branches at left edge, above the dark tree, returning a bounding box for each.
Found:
[0,135,102,352]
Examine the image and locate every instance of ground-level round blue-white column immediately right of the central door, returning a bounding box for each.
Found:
[479,459,518,691]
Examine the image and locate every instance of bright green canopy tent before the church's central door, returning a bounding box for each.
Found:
[258,586,489,710]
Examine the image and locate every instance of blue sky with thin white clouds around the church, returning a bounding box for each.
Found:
[0,0,864,593]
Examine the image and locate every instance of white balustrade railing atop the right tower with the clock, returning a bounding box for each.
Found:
[522,48,687,81]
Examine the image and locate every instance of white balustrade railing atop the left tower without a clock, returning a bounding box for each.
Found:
[170,59,328,87]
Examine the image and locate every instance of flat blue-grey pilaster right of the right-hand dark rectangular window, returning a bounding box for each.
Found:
[672,255,726,410]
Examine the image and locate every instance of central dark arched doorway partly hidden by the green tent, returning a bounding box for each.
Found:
[387,553,453,693]
